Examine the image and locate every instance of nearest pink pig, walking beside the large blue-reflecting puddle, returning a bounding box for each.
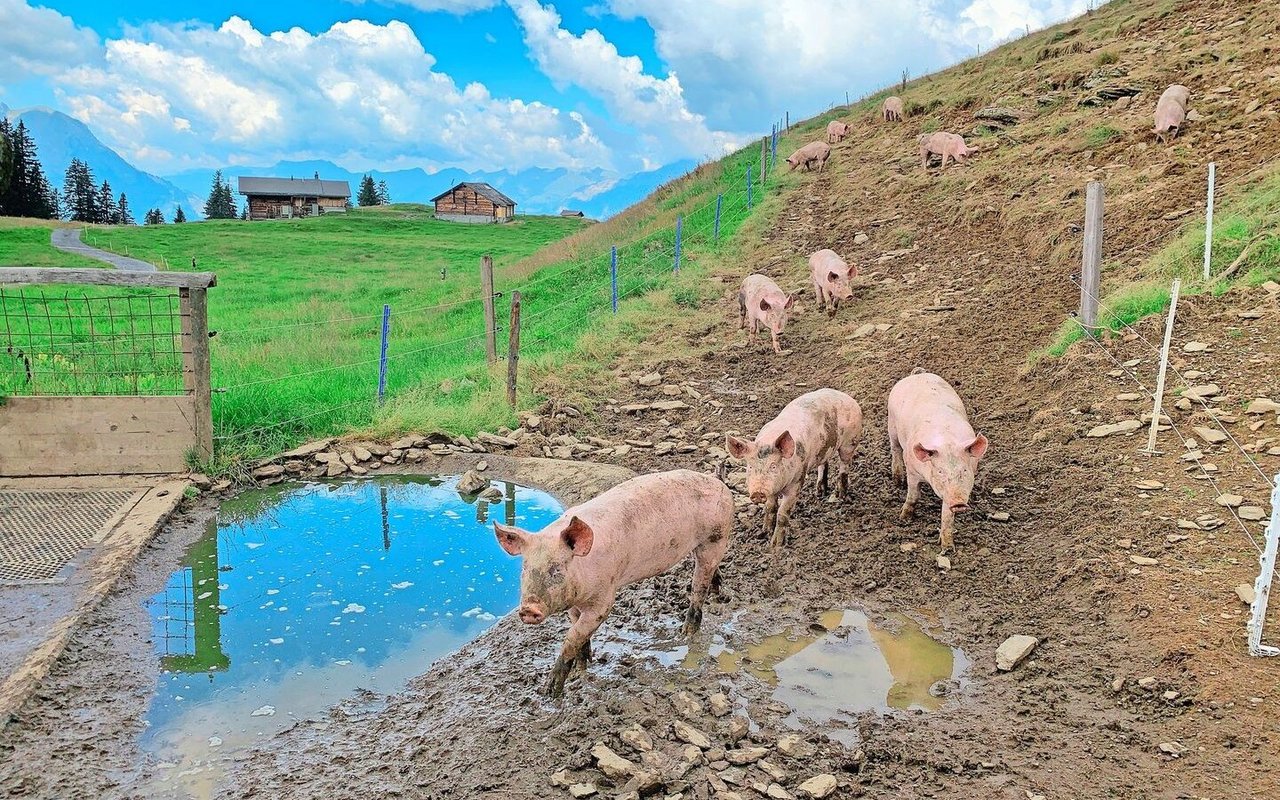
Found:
[493,470,733,698]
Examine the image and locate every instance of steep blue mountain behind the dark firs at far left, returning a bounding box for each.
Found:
[9,108,202,223]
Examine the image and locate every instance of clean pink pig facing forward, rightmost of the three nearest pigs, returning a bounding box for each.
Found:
[888,367,988,553]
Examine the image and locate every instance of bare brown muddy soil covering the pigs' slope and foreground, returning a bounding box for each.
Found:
[0,3,1280,800]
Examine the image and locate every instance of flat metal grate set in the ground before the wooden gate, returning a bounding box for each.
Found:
[0,489,143,584]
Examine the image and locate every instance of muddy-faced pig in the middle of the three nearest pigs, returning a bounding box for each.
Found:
[724,389,863,550]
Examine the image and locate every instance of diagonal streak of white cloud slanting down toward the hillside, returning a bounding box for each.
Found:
[507,0,741,164]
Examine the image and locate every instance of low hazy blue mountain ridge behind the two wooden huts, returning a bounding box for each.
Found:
[162,161,696,219]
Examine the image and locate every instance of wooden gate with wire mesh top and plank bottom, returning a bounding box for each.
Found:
[0,268,218,477]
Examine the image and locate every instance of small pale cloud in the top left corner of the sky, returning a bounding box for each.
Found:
[0,0,99,83]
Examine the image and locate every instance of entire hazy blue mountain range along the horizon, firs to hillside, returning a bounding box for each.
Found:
[0,104,696,221]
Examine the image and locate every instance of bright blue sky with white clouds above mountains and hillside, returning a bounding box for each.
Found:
[0,0,1089,175]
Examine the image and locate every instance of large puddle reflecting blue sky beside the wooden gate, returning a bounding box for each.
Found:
[142,476,562,797]
